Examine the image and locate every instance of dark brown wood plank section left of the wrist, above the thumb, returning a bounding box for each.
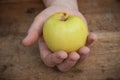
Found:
[0,2,45,36]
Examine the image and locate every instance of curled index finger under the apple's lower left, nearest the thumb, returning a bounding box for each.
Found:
[39,40,67,67]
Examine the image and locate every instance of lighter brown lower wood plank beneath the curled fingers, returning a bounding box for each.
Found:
[0,31,120,80]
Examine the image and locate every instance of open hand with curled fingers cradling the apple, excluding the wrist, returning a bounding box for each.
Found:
[23,6,96,72]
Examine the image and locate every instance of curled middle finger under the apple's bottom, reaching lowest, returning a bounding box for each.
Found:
[57,52,80,72]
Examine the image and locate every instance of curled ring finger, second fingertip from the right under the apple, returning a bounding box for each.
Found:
[78,46,90,62]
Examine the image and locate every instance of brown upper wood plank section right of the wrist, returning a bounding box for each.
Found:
[78,0,120,31]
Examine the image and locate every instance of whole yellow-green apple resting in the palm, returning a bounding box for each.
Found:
[43,12,88,53]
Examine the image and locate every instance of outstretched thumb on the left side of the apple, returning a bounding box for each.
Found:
[23,15,44,46]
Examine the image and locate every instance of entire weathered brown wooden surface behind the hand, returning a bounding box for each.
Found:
[0,0,120,80]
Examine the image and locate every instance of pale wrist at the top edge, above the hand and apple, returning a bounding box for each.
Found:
[43,0,78,10]
